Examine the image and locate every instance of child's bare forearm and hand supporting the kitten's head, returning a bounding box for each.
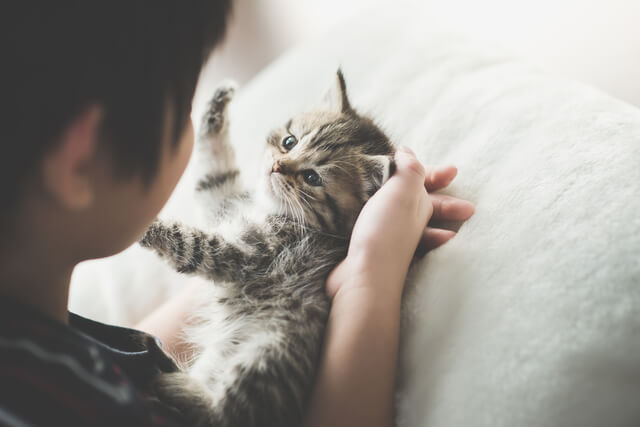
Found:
[305,152,473,427]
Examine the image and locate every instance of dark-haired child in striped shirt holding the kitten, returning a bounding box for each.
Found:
[0,0,473,426]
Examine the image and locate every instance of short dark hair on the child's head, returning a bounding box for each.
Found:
[0,0,231,226]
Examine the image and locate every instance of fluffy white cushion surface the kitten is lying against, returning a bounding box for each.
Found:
[72,4,640,427]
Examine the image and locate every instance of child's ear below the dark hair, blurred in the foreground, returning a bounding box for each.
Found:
[42,105,102,209]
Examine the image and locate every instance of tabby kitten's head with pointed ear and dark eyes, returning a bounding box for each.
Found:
[264,70,395,236]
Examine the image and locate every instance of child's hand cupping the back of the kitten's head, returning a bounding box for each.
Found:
[327,150,474,298]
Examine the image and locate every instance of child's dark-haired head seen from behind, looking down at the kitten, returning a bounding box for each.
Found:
[0,0,230,261]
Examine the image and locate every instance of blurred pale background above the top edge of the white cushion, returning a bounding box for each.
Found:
[196,0,640,106]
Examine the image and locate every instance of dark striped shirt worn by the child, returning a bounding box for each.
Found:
[0,299,184,427]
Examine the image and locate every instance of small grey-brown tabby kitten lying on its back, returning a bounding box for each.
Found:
[141,70,395,427]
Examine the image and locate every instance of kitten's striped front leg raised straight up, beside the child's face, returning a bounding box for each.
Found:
[196,83,248,223]
